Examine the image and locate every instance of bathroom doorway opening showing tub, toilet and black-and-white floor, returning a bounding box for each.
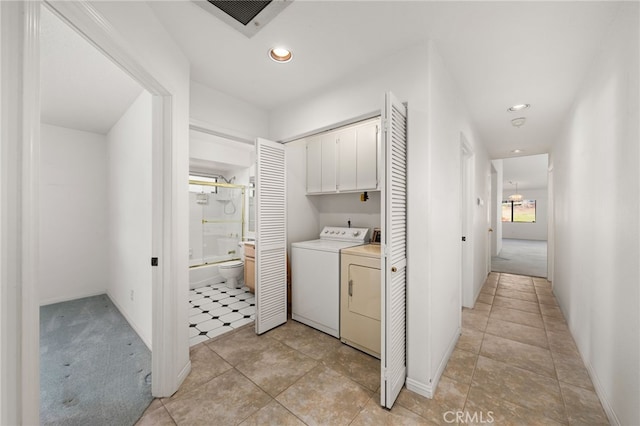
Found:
[188,128,256,346]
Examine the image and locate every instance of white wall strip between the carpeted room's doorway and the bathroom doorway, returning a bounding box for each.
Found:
[89,2,191,396]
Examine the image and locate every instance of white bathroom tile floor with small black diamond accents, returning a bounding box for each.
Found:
[189,283,256,346]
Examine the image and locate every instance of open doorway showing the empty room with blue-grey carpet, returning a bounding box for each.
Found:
[37,6,153,423]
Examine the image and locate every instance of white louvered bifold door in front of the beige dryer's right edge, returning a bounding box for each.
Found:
[380,93,407,408]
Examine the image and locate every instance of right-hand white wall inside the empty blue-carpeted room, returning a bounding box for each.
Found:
[105,91,152,348]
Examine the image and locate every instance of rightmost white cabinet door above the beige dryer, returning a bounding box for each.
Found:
[356,122,378,190]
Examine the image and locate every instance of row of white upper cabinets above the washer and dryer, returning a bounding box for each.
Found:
[307,118,380,194]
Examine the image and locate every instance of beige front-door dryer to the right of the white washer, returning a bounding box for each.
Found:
[340,244,381,358]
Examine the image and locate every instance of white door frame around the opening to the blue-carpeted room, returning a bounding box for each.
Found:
[0,1,180,424]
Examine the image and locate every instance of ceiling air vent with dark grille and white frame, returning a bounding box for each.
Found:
[194,0,292,37]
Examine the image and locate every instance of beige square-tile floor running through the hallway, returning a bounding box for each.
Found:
[138,273,609,425]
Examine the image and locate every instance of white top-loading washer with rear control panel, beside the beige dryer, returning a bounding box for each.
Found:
[291,226,369,338]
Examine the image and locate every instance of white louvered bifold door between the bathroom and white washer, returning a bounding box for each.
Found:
[255,138,287,334]
